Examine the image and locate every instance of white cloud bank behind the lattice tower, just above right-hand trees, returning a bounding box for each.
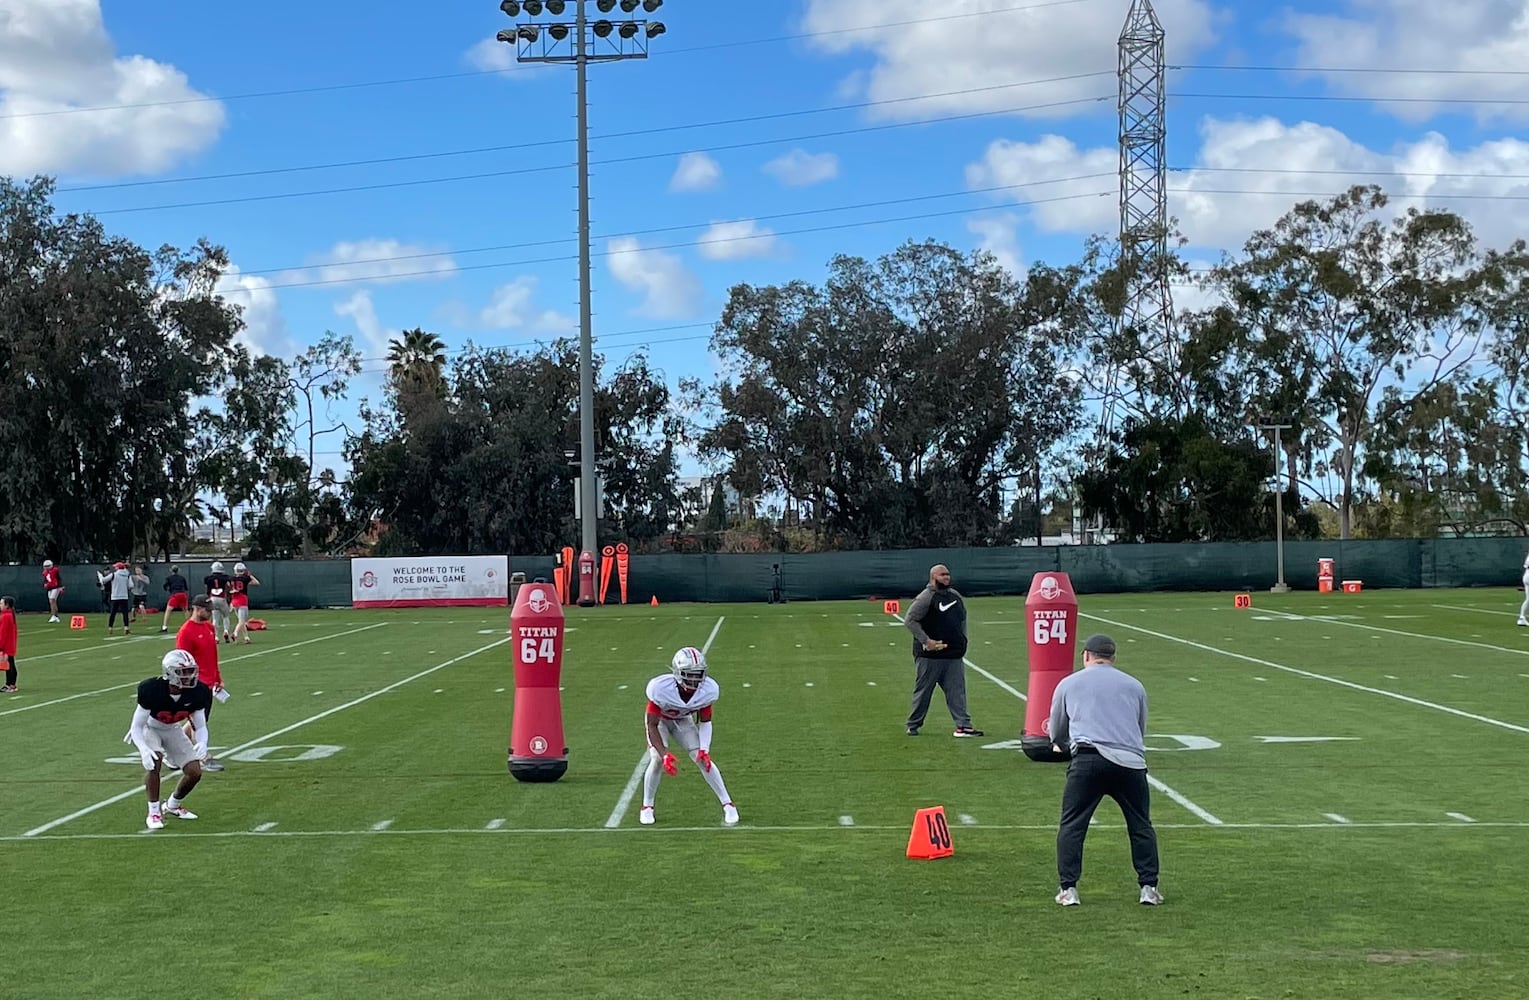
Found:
[966,118,1529,249]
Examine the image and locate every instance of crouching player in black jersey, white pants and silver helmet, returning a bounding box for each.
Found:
[122,650,213,830]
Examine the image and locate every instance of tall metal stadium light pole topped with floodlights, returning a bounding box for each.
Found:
[495,0,667,604]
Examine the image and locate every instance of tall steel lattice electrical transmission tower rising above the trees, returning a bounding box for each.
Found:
[1102,0,1179,434]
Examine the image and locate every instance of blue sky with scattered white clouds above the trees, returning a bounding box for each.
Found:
[0,0,1529,471]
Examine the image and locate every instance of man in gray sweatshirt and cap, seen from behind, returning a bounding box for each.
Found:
[1050,636,1162,907]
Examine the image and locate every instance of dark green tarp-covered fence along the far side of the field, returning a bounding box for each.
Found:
[0,538,1526,615]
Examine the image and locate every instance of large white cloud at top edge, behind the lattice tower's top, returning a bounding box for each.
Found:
[801,0,1216,119]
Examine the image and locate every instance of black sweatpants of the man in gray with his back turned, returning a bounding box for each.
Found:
[1057,746,1157,888]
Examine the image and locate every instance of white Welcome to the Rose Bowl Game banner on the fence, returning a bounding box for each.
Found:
[350,555,509,607]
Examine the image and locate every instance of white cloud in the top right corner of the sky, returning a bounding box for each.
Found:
[1286,0,1529,122]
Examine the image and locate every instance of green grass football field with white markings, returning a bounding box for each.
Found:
[0,590,1529,1000]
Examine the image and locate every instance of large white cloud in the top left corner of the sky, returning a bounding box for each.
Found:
[0,0,228,176]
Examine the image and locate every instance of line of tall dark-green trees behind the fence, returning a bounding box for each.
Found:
[0,177,1529,561]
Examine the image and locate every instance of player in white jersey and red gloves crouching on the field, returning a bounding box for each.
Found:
[638,645,739,826]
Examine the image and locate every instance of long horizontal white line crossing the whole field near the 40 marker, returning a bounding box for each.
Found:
[0,821,1529,844]
